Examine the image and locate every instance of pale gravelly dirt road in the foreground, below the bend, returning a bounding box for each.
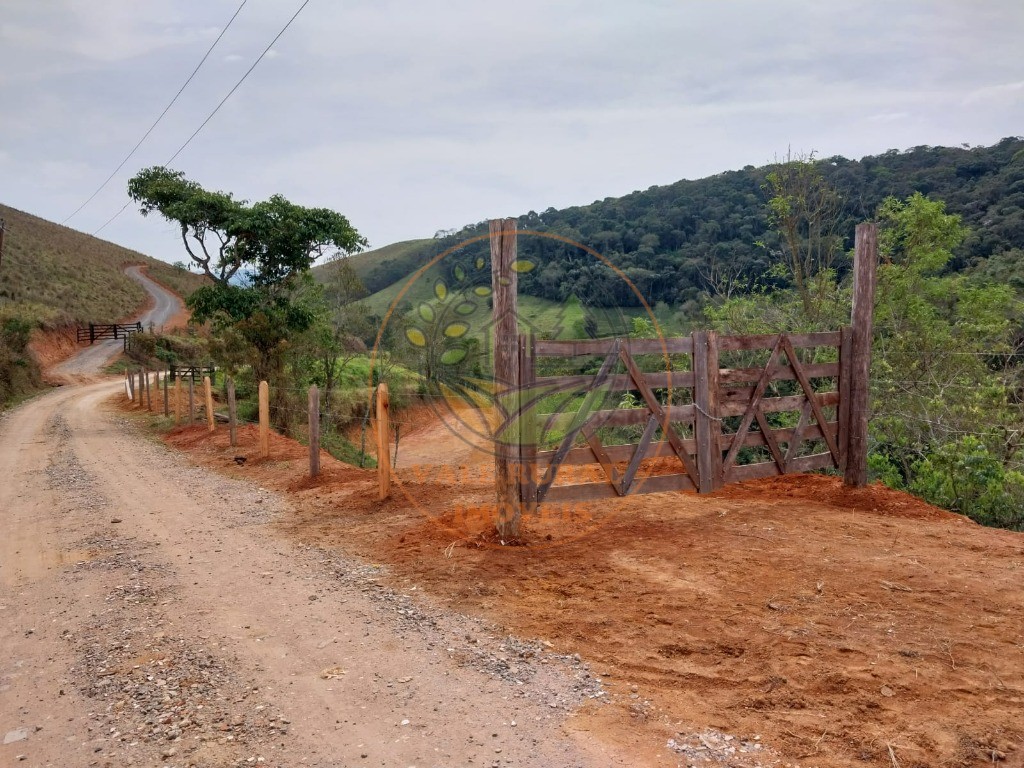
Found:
[0,391,636,767]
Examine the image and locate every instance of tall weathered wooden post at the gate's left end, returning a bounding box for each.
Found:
[489,219,522,542]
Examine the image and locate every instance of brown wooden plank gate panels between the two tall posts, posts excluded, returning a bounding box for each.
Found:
[516,329,850,507]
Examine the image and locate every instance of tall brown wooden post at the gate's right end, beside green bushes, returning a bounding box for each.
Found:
[843,222,879,487]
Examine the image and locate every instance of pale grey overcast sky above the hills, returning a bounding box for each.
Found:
[0,0,1024,261]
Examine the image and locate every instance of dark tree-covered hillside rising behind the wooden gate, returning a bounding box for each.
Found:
[325,138,1024,306]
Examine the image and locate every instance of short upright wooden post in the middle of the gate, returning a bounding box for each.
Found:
[691,331,724,494]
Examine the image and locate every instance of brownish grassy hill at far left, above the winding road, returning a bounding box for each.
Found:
[0,205,203,325]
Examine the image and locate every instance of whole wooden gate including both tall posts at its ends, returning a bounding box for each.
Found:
[490,219,878,541]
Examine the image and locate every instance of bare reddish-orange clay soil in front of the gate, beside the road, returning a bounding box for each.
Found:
[153,415,1024,768]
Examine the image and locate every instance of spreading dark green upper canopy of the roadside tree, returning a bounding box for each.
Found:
[128,166,367,288]
